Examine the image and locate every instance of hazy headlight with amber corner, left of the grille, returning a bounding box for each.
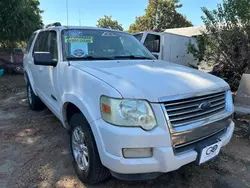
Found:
[100,96,156,130]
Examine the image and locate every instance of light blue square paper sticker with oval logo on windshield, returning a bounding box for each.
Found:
[70,42,89,57]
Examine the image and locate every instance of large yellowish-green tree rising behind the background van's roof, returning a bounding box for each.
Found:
[129,0,192,33]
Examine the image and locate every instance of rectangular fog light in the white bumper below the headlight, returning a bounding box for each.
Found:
[122,148,153,158]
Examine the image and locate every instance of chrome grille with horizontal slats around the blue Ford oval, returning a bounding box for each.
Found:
[164,91,226,127]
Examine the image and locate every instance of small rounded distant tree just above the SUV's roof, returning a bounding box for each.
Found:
[96,15,123,31]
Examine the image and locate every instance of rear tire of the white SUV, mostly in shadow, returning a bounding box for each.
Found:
[27,82,44,111]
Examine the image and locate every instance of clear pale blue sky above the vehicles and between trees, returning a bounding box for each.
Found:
[40,0,221,30]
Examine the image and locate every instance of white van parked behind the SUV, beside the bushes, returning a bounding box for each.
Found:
[133,26,204,68]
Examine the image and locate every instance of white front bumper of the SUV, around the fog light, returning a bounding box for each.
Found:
[92,119,234,174]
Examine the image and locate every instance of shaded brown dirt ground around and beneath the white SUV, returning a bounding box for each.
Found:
[0,75,250,188]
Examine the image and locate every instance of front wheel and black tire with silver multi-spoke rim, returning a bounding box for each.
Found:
[69,114,110,184]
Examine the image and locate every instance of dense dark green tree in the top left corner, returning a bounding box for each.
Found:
[0,0,43,48]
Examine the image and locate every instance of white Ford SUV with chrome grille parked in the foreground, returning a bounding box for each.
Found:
[24,24,234,183]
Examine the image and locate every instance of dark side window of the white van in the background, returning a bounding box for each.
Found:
[144,34,161,53]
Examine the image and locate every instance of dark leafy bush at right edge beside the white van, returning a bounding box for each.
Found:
[188,0,250,90]
